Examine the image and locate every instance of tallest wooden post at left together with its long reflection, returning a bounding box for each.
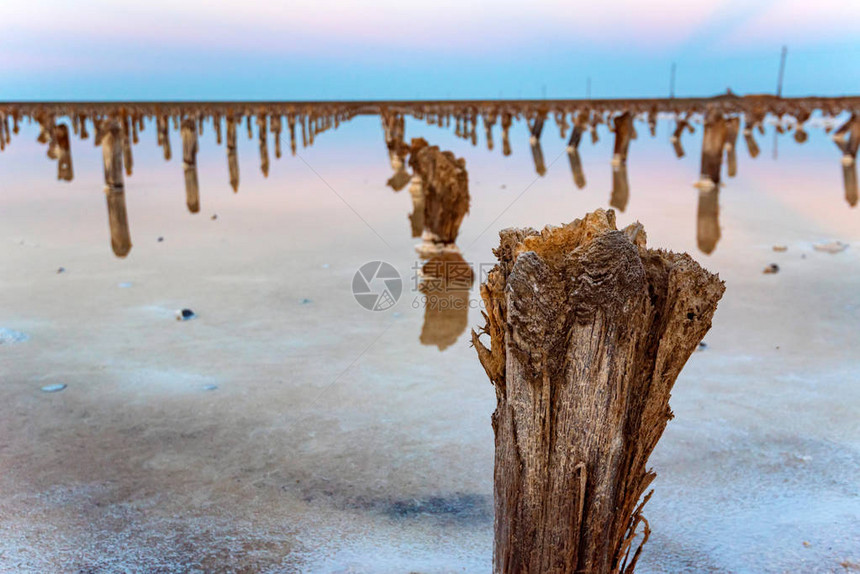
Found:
[96,119,131,257]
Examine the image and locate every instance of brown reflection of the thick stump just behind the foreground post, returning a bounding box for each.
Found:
[418,251,475,351]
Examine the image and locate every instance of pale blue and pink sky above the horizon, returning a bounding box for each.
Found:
[0,0,860,100]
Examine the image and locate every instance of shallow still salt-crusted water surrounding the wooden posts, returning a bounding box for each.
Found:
[0,110,860,572]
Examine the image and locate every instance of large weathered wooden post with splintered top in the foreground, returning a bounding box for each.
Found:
[472,210,724,574]
